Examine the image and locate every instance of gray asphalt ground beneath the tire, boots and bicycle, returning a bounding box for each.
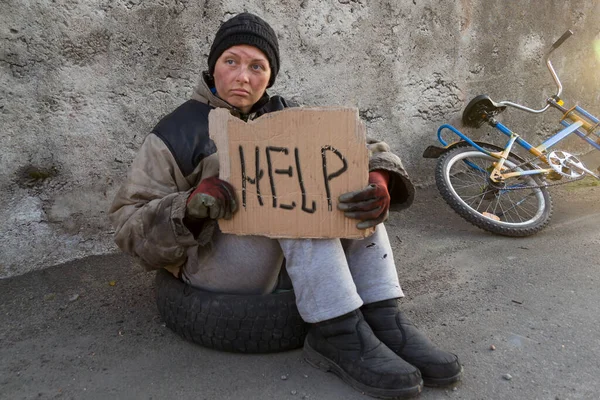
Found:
[0,184,600,400]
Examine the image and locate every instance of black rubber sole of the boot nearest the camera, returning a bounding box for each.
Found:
[303,341,423,399]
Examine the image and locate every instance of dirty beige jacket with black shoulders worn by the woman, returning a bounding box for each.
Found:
[109,74,414,271]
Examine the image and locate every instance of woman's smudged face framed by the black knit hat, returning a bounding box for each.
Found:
[213,44,271,114]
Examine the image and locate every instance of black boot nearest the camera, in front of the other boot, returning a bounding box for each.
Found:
[304,310,423,399]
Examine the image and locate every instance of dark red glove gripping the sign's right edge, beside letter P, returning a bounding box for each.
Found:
[337,170,390,229]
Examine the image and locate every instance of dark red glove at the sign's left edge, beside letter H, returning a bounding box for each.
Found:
[186,177,237,219]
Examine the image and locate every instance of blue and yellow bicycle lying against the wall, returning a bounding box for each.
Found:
[423,30,600,237]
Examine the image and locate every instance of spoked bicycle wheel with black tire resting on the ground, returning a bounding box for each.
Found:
[435,146,552,236]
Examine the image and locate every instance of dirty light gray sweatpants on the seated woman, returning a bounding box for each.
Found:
[182,224,404,323]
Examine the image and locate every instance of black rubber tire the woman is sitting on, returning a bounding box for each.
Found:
[156,270,308,353]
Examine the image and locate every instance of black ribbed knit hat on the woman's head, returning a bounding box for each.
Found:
[208,13,279,87]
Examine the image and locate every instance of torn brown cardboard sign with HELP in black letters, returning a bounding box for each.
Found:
[209,108,374,238]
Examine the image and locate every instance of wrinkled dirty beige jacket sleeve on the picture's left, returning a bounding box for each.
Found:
[109,134,198,270]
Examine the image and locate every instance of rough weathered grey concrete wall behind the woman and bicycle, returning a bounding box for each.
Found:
[0,0,600,278]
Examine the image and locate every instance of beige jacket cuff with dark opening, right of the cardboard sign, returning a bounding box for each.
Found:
[367,137,415,210]
